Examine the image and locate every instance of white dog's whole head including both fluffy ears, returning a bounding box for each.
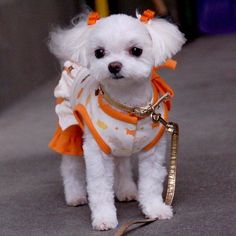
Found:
[50,14,185,85]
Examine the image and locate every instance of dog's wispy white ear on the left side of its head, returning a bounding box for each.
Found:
[48,20,89,67]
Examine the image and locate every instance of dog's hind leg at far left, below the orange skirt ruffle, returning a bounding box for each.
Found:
[61,155,87,206]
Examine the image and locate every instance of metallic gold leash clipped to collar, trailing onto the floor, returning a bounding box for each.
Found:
[114,111,179,236]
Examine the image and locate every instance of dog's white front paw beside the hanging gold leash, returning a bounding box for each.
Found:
[142,203,173,220]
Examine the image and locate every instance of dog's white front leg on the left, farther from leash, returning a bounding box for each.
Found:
[83,130,118,230]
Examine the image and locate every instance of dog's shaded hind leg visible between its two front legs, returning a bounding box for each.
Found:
[114,157,138,201]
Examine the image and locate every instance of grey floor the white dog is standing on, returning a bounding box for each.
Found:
[0,35,236,236]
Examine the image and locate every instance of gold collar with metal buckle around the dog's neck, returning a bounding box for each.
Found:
[95,84,171,118]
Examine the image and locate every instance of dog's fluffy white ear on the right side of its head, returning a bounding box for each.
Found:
[145,19,185,66]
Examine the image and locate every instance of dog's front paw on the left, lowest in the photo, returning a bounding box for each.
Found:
[92,207,118,231]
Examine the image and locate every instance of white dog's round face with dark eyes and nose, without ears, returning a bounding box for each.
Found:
[87,15,155,83]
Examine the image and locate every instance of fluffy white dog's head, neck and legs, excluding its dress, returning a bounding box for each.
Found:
[50,11,185,230]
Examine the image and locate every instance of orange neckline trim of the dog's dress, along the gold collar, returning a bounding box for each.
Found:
[98,83,159,124]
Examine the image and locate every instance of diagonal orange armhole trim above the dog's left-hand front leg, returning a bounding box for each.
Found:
[75,104,111,154]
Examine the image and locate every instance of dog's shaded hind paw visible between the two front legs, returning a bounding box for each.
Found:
[116,182,138,202]
